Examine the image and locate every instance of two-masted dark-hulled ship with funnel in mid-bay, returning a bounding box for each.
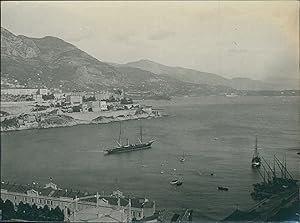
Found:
[104,122,155,155]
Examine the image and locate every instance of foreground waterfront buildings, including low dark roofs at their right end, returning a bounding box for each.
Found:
[1,181,193,223]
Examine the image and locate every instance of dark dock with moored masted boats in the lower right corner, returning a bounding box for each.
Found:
[222,156,300,222]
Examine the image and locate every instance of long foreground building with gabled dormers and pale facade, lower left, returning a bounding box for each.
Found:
[1,182,155,222]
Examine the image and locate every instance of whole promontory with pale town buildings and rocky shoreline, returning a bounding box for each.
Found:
[0,88,161,131]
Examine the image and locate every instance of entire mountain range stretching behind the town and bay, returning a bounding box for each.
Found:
[1,27,290,95]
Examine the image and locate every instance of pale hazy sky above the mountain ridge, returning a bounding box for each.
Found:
[1,1,299,82]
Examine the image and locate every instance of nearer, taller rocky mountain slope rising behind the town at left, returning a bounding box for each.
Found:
[1,27,126,90]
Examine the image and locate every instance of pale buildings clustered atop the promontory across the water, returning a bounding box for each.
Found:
[1,88,149,112]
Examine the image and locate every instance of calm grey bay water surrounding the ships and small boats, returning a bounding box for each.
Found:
[1,97,299,220]
